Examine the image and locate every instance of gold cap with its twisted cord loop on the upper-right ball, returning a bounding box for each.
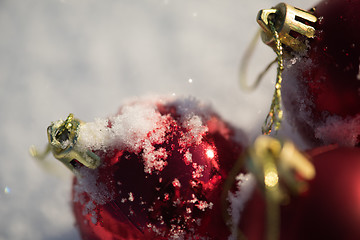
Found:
[240,3,317,135]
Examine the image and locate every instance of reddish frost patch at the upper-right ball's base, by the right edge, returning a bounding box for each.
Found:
[315,114,360,146]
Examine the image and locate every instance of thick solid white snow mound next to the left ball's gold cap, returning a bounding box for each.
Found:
[77,102,168,153]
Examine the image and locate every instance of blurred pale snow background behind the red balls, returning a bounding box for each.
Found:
[0,0,317,240]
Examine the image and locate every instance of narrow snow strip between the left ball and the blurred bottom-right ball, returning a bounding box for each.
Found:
[228,173,256,240]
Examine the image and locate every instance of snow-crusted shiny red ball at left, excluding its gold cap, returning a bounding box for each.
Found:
[73,98,244,239]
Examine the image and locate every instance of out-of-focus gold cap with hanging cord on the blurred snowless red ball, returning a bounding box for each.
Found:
[246,136,316,240]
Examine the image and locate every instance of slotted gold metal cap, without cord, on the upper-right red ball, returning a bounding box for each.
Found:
[256,3,317,52]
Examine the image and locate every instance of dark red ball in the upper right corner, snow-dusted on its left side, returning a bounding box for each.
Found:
[282,0,360,146]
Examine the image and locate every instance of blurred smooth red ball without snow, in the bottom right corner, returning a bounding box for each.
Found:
[240,145,360,240]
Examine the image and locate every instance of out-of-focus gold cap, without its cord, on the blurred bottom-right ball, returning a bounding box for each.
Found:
[247,135,315,193]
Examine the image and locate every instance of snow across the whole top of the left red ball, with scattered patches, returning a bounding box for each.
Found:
[76,96,217,173]
